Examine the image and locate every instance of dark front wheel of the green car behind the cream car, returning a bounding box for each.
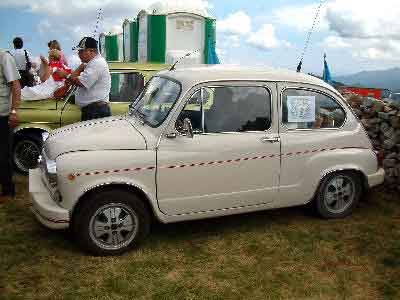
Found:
[14,140,40,172]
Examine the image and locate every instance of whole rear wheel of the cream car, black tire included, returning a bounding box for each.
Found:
[314,171,362,219]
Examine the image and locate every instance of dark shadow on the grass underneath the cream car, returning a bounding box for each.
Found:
[142,188,395,252]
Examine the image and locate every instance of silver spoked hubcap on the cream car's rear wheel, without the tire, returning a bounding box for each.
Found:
[324,175,356,214]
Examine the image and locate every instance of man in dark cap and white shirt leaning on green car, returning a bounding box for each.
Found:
[57,37,111,121]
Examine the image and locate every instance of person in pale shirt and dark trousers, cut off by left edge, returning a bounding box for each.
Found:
[0,49,21,203]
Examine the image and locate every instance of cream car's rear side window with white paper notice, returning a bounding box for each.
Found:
[282,89,346,129]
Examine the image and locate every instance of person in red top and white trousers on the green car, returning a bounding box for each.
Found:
[21,49,72,101]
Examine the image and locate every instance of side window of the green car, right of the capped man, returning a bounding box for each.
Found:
[110,73,144,102]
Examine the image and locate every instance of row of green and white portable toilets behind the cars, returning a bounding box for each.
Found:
[116,3,216,64]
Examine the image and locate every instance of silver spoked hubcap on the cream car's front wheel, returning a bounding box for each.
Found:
[89,203,139,250]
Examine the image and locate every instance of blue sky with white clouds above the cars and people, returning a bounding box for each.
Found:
[0,0,400,79]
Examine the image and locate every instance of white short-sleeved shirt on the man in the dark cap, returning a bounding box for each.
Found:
[75,54,111,107]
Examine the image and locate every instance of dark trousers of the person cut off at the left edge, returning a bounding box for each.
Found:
[0,116,15,195]
